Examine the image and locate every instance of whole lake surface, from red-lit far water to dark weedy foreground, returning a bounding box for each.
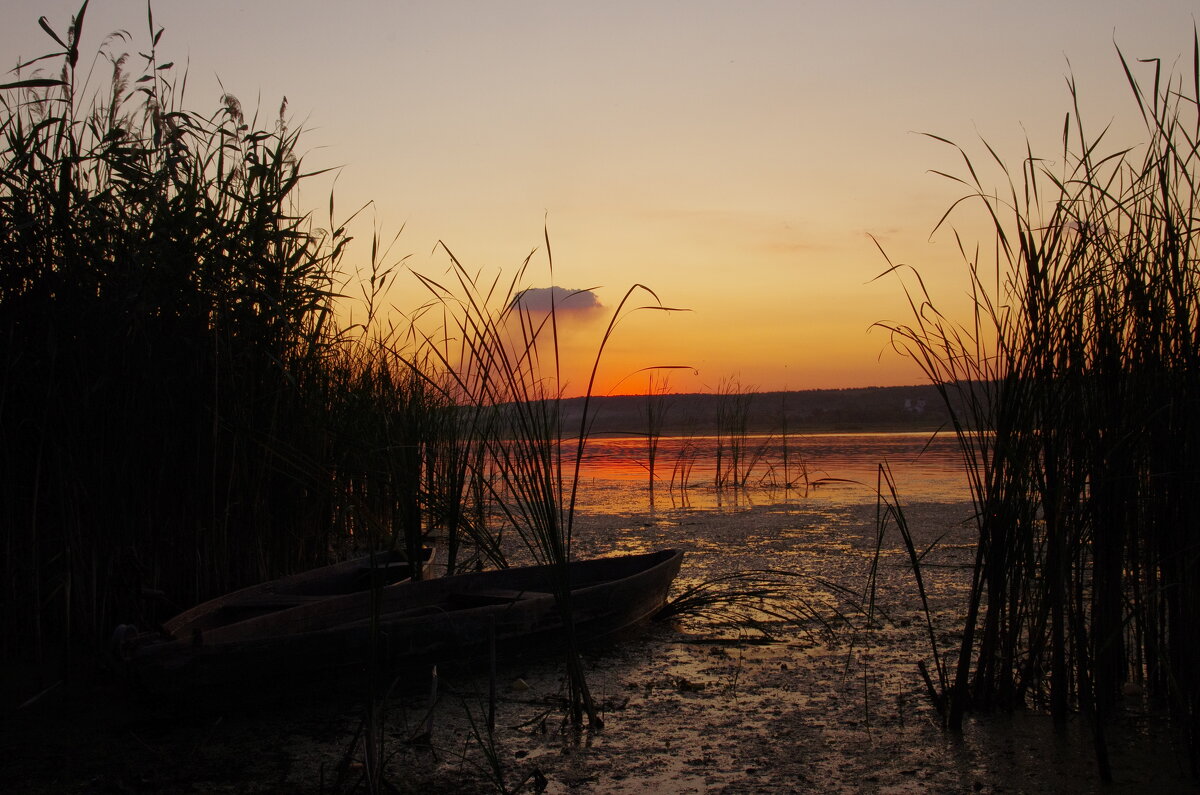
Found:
[25,434,1171,795]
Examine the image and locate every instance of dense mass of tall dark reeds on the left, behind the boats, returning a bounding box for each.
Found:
[0,2,446,682]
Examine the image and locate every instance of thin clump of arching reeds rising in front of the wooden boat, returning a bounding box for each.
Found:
[412,241,676,728]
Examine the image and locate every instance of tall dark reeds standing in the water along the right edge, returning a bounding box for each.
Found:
[873,44,1200,776]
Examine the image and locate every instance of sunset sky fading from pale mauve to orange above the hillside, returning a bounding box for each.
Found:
[0,0,1196,391]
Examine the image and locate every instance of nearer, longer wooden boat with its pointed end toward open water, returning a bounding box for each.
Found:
[122,550,683,692]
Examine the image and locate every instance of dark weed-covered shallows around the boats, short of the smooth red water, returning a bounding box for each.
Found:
[0,500,1195,793]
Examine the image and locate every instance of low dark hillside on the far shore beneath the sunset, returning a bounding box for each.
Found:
[564,384,948,435]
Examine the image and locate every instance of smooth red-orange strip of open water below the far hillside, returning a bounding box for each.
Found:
[566,432,970,513]
